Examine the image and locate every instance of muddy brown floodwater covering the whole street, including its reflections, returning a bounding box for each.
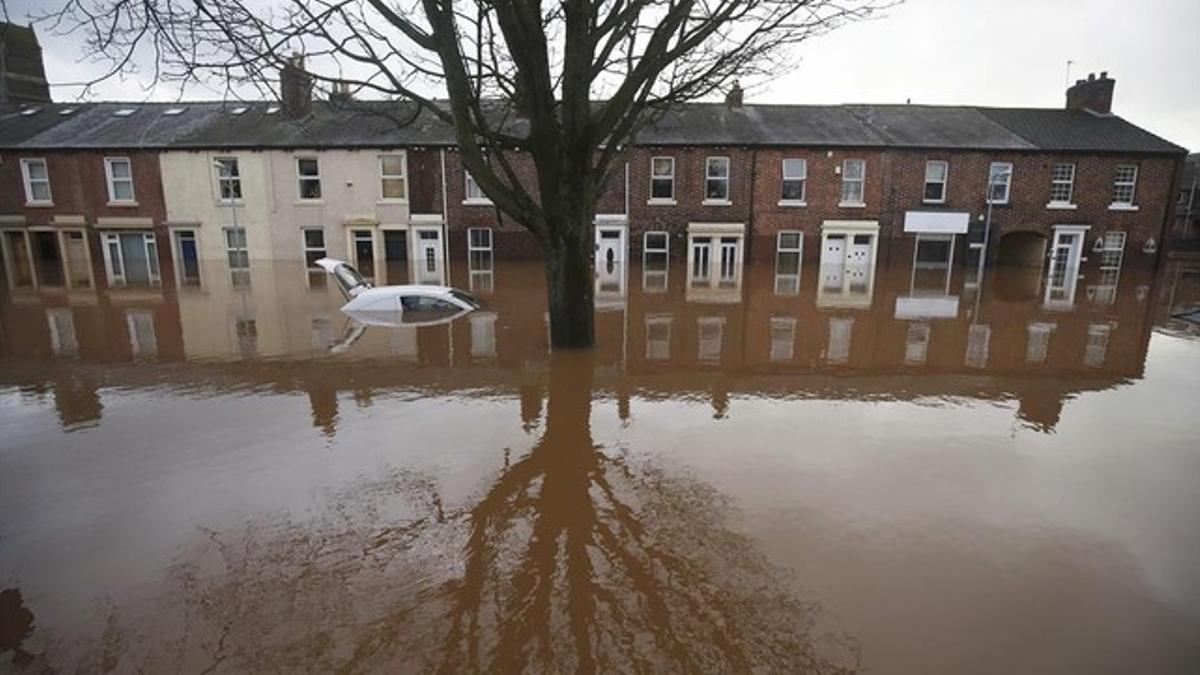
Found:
[0,254,1200,673]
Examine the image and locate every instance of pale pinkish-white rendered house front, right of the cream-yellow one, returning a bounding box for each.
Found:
[264,149,409,261]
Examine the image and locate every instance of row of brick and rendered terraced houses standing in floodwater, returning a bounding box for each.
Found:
[0,69,1184,289]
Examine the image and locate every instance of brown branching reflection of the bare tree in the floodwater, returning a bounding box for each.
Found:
[65,354,857,673]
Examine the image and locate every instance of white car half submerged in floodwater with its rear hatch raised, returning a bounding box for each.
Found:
[317,258,481,325]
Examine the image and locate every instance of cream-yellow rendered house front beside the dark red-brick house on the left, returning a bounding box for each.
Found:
[158,150,276,261]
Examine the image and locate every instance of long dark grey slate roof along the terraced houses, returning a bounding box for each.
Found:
[0,101,1184,154]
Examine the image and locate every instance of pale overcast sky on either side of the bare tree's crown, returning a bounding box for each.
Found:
[7,0,1200,151]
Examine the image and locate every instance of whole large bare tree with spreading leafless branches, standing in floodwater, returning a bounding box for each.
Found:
[41,0,880,347]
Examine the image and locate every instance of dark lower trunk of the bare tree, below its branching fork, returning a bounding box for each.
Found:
[545,208,595,350]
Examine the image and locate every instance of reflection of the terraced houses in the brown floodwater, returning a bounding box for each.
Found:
[2,251,1176,435]
